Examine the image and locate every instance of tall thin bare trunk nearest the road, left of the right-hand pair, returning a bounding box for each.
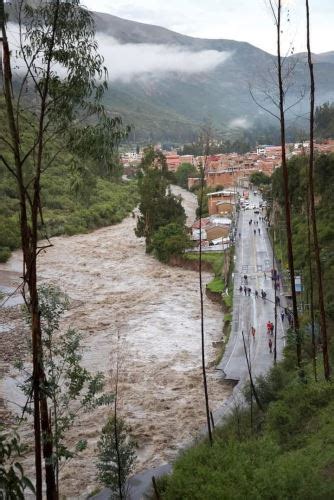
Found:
[271,0,302,368]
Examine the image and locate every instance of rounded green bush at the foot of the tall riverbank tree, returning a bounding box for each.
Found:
[152,222,191,262]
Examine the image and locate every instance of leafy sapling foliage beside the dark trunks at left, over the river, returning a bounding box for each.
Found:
[17,285,113,471]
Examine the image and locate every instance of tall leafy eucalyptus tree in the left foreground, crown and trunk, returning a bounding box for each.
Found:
[0,0,126,499]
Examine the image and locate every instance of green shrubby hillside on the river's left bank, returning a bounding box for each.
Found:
[0,101,139,262]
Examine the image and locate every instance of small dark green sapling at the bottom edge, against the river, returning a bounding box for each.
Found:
[96,417,136,500]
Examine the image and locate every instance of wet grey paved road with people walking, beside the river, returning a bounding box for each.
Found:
[218,195,286,381]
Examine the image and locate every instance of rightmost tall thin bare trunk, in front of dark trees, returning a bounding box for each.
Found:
[306,0,330,380]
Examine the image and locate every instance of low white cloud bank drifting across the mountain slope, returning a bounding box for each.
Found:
[96,33,231,81]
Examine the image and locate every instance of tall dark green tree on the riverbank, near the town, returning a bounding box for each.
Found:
[135,147,186,252]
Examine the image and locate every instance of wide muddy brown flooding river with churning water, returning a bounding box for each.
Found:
[0,188,230,498]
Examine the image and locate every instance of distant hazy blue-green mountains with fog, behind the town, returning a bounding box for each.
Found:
[5,5,334,142]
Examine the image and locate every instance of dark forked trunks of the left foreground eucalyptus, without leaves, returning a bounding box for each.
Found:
[0,0,57,500]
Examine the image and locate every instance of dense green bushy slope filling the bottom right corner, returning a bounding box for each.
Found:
[161,356,334,500]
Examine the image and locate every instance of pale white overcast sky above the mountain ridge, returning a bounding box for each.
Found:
[82,0,334,53]
